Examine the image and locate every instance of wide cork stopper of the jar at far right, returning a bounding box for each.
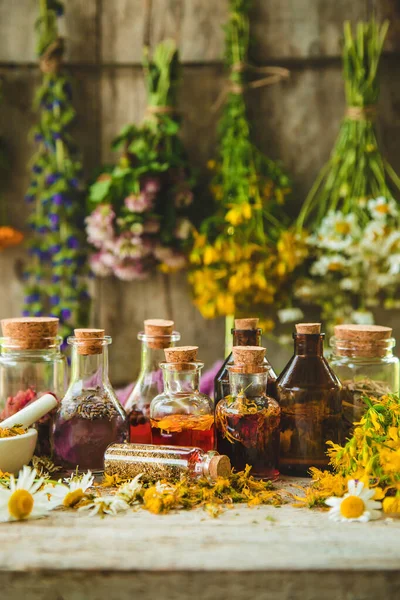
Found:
[335,324,394,358]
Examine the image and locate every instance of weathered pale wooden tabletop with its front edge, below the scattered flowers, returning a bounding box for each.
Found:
[0,478,400,600]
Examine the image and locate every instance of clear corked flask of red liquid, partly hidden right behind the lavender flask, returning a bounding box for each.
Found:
[125,319,181,444]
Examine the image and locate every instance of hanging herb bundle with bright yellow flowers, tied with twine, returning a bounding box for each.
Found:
[189,0,303,336]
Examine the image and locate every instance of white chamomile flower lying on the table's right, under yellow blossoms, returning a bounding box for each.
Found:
[325,479,382,523]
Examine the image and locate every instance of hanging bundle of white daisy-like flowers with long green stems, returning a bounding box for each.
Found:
[298,20,400,323]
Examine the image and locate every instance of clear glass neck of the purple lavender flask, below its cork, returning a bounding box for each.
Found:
[71,346,109,389]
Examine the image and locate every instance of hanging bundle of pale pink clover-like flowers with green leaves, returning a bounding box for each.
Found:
[86,40,194,281]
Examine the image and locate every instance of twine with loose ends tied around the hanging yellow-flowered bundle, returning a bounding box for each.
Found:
[211,62,290,112]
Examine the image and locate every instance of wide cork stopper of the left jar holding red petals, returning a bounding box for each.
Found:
[1,317,58,350]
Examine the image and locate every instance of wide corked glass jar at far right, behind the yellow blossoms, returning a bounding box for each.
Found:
[330,325,399,437]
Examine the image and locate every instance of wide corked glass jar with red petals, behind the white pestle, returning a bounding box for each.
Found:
[0,317,67,456]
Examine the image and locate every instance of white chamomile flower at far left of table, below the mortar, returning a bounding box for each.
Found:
[0,466,55,522]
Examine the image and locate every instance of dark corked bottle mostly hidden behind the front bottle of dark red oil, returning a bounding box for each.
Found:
[214,318,277,405]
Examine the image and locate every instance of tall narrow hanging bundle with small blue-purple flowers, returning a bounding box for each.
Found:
[24,0,89,337]
